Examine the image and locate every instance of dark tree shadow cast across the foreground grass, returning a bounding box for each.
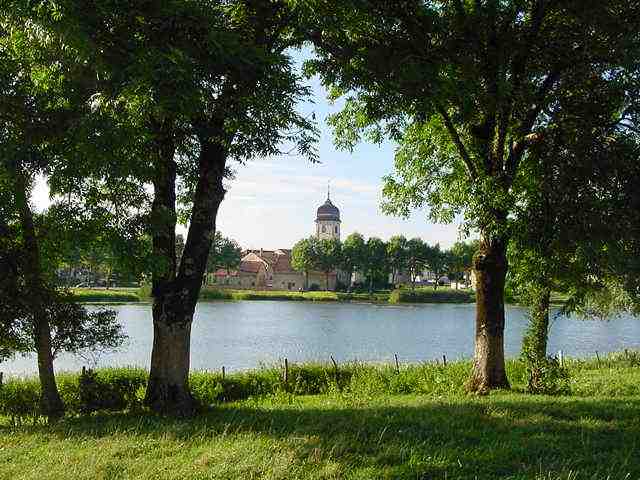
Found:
[5,395,640,479]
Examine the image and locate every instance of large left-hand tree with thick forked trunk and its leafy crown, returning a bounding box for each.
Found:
[58,0,316,415]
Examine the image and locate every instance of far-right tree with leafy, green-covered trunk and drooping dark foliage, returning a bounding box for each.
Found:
[509,124,640,393]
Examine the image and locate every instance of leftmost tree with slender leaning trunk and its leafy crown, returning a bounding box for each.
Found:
[0,2,132,419]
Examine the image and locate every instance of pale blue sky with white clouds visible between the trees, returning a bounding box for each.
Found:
[33,51,459,249]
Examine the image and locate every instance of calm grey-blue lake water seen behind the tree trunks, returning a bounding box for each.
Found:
[0,301,640,375]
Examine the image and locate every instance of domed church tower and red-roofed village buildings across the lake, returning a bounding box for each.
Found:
[206,193,347,291]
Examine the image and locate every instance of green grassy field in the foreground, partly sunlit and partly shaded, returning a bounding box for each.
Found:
[0,356,640,480]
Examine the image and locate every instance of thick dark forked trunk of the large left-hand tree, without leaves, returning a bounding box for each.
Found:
[145,127,226,416]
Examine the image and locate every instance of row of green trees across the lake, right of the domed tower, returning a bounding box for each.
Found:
[291,232,478,293]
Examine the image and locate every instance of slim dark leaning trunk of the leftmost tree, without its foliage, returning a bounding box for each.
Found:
[14,167,64,420]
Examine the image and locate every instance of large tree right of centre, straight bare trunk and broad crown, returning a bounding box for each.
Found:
[307,0,640,391]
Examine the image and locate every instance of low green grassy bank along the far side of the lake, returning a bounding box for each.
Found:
[72,287,475,304]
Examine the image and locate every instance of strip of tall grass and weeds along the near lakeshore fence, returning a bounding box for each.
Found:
[0,352,640,419]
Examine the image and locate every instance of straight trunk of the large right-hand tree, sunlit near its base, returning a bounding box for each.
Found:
[467,233,509,393]
